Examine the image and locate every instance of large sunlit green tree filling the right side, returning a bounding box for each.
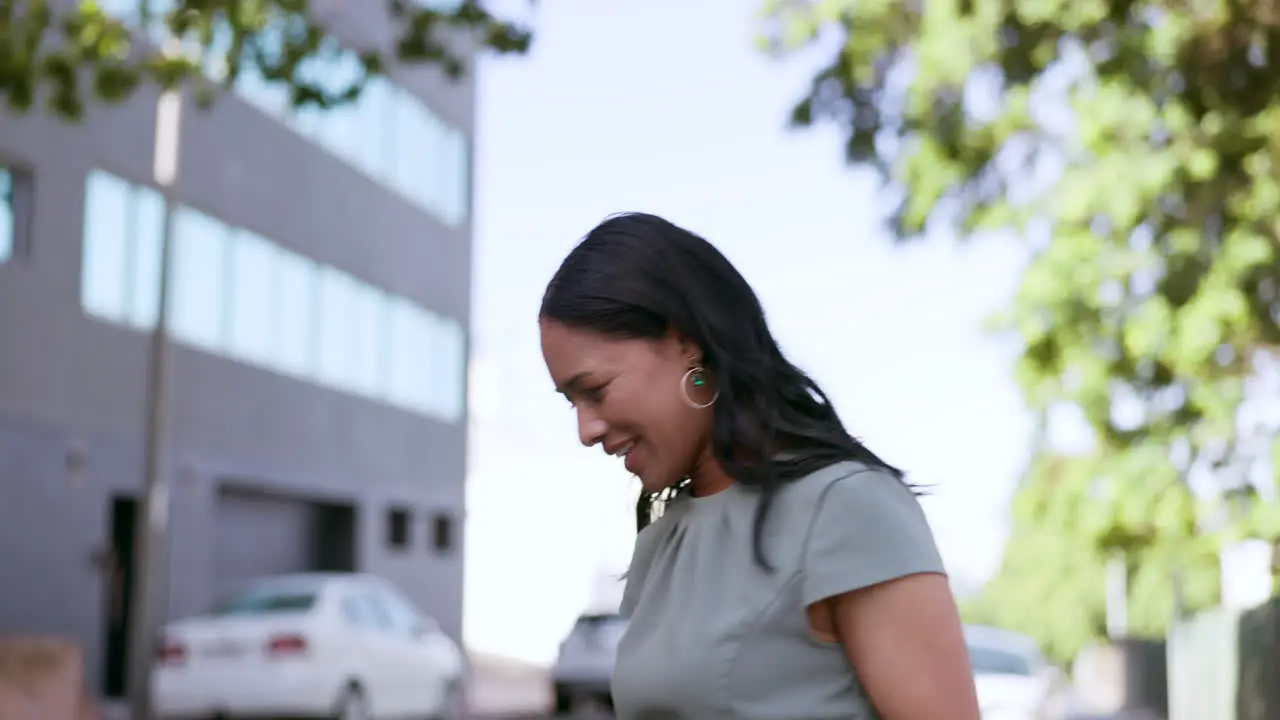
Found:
[765,0,1280,652]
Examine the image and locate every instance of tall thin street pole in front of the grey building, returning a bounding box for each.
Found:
[127,68,182,720]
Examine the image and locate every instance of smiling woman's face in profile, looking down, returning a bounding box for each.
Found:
[539,318,713,492]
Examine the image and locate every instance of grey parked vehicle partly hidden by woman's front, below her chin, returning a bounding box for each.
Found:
[552,614,627,715]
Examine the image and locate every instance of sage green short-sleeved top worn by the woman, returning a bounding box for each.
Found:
[613,462,943,720]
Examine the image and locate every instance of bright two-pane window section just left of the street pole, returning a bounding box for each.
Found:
[81,170,164,329]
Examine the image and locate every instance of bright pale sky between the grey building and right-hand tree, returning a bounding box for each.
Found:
[465,0,1030,662]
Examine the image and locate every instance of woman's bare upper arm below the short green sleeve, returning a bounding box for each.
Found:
[829,573,980,720]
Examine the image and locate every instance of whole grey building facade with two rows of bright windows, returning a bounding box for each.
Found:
[0,3,474,696]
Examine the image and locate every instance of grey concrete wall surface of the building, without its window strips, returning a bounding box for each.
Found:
[0,0,474,685]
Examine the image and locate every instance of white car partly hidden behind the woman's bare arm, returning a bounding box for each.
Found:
[964,625,1061,720]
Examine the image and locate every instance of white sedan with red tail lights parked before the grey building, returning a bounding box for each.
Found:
[151,573,463,720]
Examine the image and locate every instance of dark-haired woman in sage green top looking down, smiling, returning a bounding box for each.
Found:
[540,214,979,720]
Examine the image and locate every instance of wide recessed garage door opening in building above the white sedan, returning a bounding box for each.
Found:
[214,488,356,597]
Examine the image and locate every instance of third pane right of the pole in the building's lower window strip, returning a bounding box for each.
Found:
[275,249,317,378]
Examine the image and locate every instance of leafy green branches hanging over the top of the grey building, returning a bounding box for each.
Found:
[0,0,531,120]
